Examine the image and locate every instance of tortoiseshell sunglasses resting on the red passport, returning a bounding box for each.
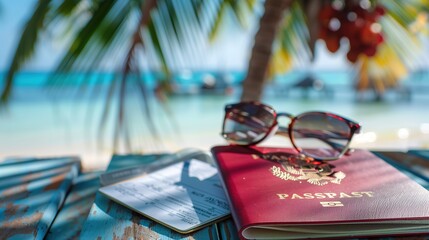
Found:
[222,102,361,161]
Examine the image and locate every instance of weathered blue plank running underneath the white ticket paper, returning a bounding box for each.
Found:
[80,154,219,239]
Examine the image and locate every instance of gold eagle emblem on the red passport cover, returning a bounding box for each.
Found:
[254,154,346,186]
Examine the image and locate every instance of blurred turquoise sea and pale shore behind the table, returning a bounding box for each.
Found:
[0,71,429,168]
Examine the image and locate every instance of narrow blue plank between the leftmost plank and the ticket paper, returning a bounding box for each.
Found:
[46,172,101,240]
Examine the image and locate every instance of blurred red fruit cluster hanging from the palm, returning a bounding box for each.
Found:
[319,2,385,62]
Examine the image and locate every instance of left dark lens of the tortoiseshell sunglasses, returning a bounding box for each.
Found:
[222,104,275,145]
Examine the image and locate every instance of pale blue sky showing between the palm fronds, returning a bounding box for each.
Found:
[0,0,347,72]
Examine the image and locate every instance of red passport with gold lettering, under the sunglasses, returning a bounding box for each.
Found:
[212,146,429,239]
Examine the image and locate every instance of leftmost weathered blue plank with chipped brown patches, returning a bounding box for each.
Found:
[0,157,80,239]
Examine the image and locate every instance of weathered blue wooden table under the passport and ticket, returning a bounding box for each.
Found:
[0,150,429,239]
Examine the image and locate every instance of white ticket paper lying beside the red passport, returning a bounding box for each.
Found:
[100,159,230,233]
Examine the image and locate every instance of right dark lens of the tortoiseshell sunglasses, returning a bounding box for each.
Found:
[292,113,351,159]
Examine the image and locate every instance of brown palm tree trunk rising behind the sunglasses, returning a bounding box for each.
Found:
[241,0,292,101]
